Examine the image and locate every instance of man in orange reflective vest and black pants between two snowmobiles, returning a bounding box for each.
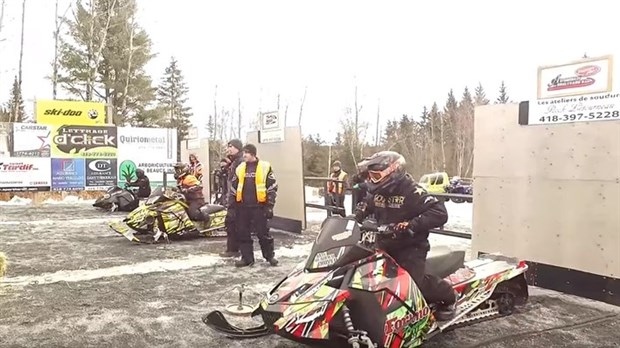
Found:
[228,144,278,267]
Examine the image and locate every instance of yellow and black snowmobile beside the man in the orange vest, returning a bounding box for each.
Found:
[109,187,227,243]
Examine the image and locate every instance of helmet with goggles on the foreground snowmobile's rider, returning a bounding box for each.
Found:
[357,151,407,194]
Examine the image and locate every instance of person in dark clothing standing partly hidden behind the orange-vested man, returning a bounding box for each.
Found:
[220,139,243,257]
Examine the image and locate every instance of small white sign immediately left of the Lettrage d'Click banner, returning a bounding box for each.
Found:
[12,123,52,157]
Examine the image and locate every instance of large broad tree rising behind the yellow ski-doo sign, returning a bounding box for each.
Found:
[58,0,155,126]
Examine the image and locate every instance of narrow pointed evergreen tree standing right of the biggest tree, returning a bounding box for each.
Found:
[157,57,192,154]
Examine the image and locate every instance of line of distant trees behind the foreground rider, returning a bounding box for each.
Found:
[303,81,511,185]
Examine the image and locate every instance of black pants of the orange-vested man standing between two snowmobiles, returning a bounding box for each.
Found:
[235,205,274,263]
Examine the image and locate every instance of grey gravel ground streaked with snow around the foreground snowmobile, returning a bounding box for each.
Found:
[0,204,620,348]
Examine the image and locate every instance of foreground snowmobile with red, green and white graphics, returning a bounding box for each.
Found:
[203,217,528,348]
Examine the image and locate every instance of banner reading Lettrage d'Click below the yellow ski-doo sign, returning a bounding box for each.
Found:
[51,125,118,158]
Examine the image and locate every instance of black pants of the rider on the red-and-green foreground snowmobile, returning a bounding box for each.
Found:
[387,245,456,305]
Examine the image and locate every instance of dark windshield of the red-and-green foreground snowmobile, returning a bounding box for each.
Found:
[305,216,370,272]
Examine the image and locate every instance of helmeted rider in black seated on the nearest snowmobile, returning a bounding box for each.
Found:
[355,151,457,321]
